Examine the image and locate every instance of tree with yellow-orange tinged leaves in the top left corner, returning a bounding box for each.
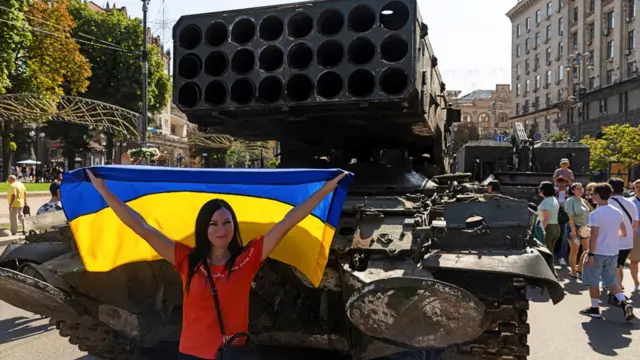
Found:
[0,0,91,176]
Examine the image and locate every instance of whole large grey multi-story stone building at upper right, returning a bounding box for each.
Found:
[507,0,640,138]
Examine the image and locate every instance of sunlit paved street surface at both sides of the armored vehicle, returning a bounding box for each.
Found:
[0,243,640,360]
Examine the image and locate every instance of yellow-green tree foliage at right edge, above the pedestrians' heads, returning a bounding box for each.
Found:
[582,124,640,170]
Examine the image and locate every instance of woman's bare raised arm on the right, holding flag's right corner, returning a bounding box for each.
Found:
[260,172,347,261]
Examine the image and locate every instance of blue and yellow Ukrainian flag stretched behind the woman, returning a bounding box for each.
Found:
[60,166,353,286]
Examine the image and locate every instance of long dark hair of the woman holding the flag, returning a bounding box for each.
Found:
[187,199,244,291]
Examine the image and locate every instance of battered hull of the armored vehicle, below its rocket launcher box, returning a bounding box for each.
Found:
[0,165,563,359]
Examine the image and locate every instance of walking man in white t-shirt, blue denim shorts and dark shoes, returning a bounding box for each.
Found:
[580,183,634,321]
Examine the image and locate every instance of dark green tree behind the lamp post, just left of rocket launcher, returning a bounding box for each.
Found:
[69,0,171,113]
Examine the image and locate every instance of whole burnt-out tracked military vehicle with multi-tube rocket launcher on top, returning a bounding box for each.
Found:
[0,0,564,360]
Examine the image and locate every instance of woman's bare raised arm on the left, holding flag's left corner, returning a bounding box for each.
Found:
[87,170,176,264]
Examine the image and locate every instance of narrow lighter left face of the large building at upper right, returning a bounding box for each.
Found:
[507,0,572,136]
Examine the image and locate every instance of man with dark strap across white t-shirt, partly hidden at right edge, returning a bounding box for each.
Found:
[609,178,639,288]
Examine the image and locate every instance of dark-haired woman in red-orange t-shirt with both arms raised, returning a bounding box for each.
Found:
[87,170,346,360]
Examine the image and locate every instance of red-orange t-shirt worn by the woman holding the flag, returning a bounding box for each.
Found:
[174,236,264,359]
